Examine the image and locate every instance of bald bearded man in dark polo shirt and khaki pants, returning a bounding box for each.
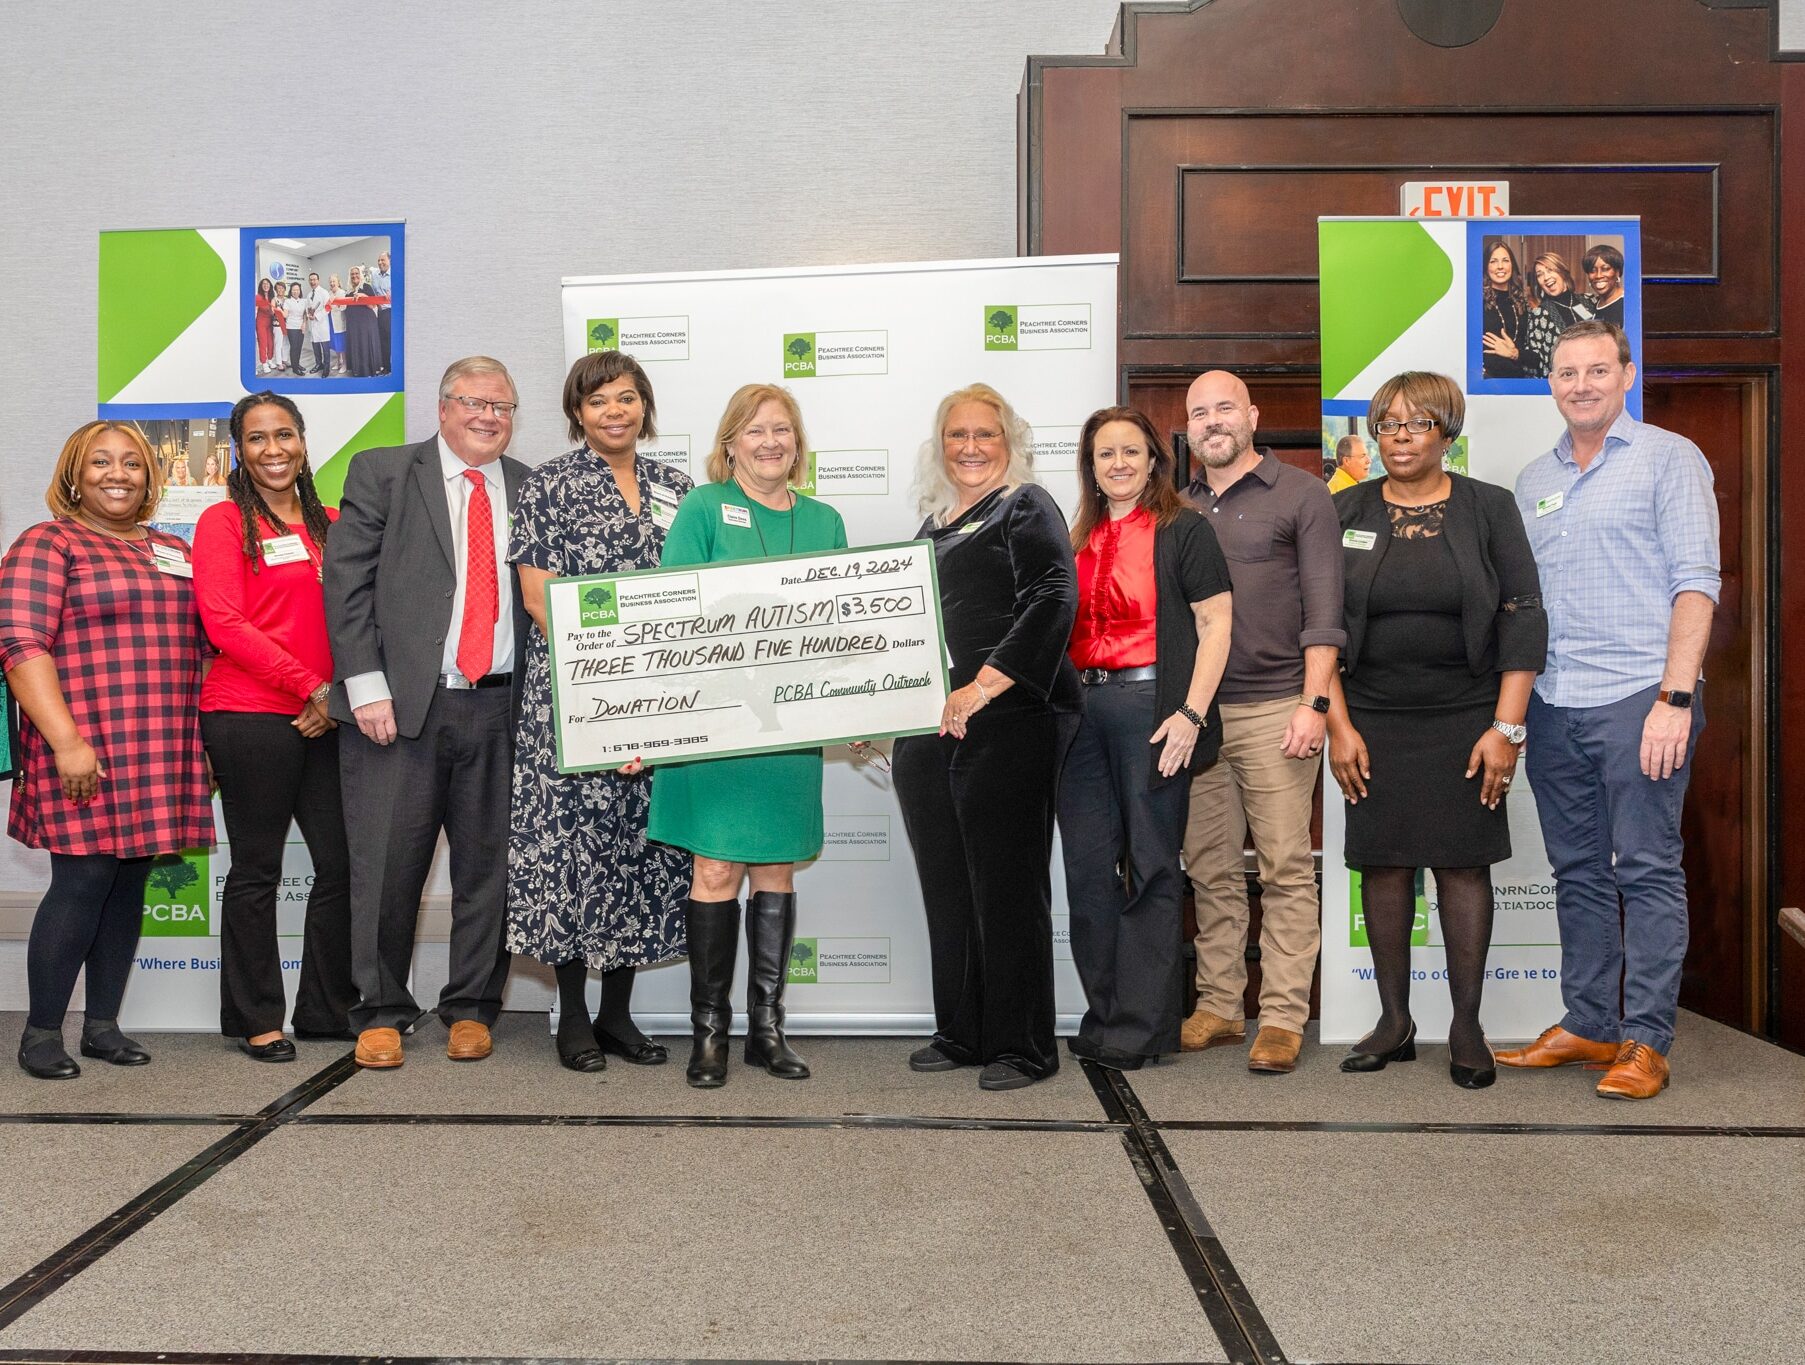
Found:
[1182,370,1347,1073]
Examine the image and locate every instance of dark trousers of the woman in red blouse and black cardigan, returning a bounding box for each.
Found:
[1060,679,1191,1056]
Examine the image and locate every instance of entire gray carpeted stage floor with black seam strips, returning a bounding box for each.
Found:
[0,1015,1805,1365]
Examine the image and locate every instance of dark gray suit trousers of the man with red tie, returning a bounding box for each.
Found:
[339,688,514,1031]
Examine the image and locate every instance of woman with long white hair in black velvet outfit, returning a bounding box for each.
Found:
[893,385,1081,1091]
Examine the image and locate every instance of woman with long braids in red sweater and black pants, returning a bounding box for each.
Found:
[195,394,357,1062]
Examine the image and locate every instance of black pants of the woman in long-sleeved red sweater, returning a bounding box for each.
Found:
[200,711,357,1038]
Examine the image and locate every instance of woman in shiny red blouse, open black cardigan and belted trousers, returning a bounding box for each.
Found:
[1060,408,1231,1071]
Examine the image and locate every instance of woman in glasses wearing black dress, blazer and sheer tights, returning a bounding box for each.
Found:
[1328,370,1549,1089]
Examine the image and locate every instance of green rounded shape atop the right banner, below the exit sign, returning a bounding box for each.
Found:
[1318,222,1455,397]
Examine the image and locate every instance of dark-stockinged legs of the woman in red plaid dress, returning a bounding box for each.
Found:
[25,852,150,1029]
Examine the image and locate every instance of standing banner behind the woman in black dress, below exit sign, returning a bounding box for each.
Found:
[1318,217,1643,1042]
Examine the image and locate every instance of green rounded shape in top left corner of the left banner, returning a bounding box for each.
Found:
[96,228,226,403]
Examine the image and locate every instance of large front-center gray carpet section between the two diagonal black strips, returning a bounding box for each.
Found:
[0,1127,1220,1361]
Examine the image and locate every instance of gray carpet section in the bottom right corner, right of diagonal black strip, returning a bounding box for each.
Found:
[1166,1134,1805,1365]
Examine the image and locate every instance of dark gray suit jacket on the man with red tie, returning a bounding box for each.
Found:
[321,433,532,738]
